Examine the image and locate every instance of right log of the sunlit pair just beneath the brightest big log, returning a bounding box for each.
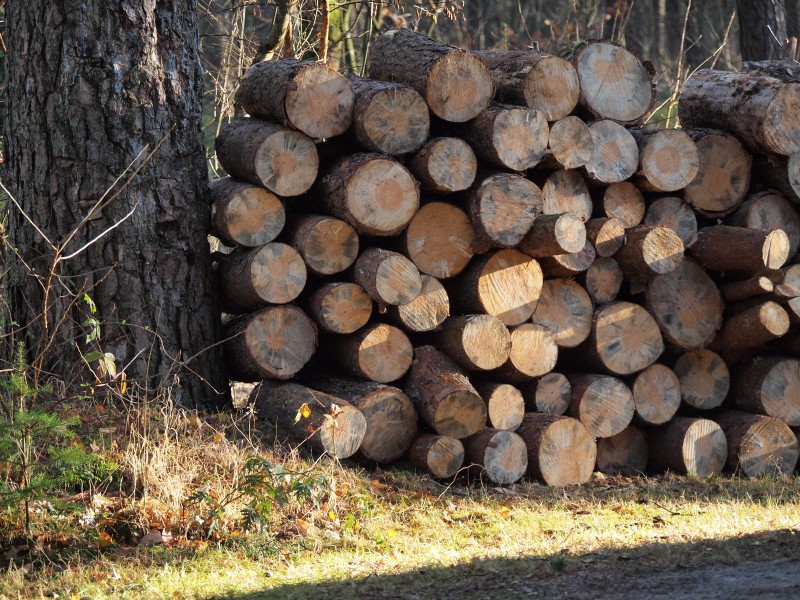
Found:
[491,323,558,383]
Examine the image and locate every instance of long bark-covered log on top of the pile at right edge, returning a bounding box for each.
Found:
[678,69,800,156]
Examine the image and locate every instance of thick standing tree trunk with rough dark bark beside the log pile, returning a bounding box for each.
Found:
[3,0,227,406]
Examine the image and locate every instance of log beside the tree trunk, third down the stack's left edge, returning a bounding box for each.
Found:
[208,177,286,248]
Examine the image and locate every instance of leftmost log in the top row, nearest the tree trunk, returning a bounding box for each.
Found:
[236,58,354,139]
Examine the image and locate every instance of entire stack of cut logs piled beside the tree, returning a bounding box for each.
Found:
[211,29,800,485]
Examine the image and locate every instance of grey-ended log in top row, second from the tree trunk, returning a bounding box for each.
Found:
[347,75,431,155]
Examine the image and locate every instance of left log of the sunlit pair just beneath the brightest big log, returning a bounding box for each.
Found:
[436,315,511,371]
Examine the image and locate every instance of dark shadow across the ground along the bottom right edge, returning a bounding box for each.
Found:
[216,528,800,600]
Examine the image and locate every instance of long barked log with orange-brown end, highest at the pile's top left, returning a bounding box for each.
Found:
[367,29,494,123]
